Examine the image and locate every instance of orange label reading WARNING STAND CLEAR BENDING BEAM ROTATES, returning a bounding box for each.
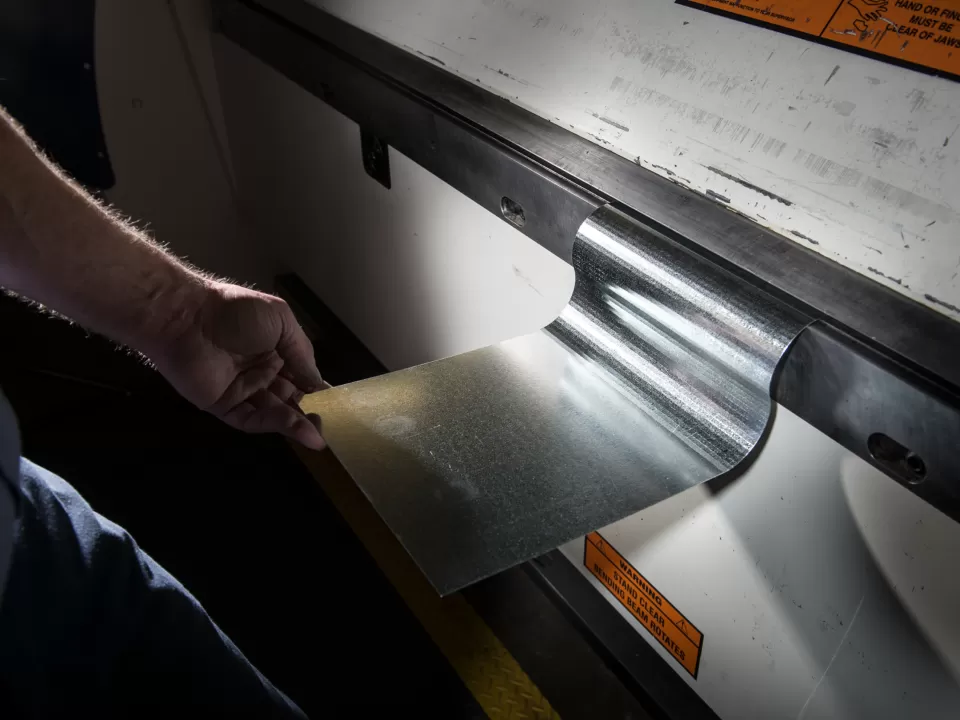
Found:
[583,533,703,678]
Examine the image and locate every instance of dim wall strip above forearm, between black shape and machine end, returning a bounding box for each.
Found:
[95,0,276,288]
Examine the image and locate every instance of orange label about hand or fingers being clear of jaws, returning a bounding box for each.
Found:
[678,0,960,79]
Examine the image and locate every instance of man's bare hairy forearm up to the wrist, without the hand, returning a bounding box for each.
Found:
[0,108,205,354]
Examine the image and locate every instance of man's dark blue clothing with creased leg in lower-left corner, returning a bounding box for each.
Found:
[0,394,306,720]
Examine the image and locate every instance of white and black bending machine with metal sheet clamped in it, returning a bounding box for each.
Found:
[215,0,960,718]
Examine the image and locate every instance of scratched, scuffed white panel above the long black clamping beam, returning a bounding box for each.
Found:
[313,0,960,318]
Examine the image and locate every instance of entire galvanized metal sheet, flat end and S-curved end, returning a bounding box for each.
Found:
[305,206,808,594]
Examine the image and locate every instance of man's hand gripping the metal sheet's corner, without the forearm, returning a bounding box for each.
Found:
[144,281,329,450]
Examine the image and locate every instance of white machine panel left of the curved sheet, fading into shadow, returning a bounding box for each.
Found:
[215,37,573,370]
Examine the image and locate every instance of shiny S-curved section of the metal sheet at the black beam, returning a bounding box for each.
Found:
[547,205,807,472]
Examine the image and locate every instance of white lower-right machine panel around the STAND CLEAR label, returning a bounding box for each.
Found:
[562,408,960,720]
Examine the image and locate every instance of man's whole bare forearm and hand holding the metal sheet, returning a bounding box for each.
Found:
[0,108,327,449]
